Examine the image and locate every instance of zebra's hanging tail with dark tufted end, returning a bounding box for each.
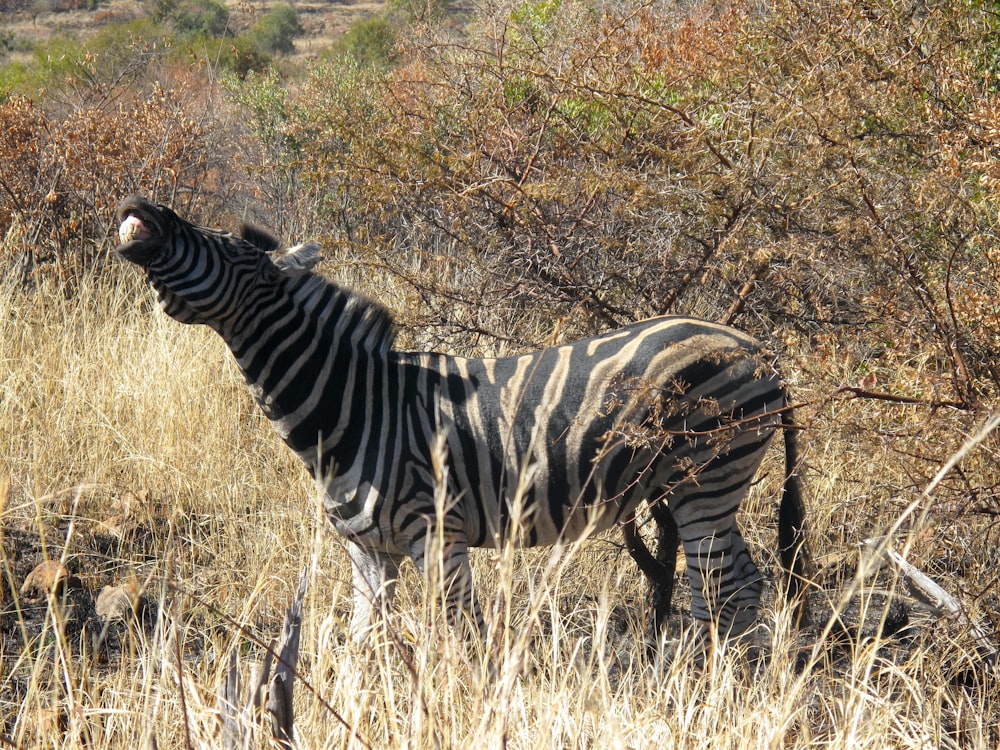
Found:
[778,409,809,624]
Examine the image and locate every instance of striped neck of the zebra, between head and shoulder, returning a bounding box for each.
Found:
[220,274,392,472]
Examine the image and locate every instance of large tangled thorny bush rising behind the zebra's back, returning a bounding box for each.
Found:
[280,0,1000,404]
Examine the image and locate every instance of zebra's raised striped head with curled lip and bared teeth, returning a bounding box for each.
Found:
[117,196,319,329]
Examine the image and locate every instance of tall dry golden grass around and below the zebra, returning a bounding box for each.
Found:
[0,269,1000,748]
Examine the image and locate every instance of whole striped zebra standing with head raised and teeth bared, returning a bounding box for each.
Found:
[117,196,806,644]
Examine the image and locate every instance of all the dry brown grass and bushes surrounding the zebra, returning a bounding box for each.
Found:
[0,0,1000,748]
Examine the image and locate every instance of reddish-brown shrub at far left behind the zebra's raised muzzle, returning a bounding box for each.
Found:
[0,78,220,283]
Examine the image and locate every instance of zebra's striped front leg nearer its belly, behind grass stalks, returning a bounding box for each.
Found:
[412,538,486,640]
